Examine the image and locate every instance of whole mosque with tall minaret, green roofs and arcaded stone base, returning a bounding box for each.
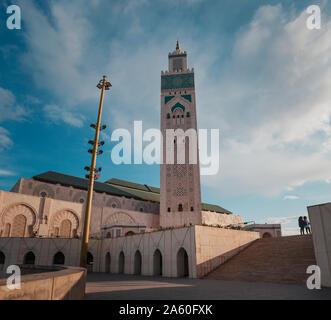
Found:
[0,42,281,277]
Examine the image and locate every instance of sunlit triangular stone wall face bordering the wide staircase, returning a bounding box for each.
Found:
[195,226,260,278]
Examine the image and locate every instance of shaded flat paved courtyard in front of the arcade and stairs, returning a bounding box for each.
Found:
[85,273,331,300]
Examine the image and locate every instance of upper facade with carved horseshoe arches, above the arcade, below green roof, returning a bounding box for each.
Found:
[0,191,159,238]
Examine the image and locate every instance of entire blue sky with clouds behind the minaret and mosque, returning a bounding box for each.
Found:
[0,0,331,235]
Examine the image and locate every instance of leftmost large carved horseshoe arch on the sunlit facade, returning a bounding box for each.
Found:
[1,203,37,237]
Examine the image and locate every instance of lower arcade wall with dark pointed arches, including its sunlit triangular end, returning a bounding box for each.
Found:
[0,226,259,278]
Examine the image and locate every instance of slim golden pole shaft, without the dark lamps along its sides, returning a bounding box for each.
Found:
[80,76,111,268]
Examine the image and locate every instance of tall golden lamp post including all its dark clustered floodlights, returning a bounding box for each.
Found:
[80,76,112,268]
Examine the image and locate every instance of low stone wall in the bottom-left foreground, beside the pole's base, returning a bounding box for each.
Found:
[0,266,86,300]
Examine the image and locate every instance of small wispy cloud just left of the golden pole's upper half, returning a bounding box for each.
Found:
[43,105,84,127]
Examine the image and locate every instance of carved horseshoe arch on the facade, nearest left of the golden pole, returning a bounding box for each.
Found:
[49,210,79,238]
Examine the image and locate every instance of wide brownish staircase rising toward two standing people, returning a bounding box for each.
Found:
[205,235,316,284]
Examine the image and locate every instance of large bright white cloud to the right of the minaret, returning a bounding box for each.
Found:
[197,5,331,195]
